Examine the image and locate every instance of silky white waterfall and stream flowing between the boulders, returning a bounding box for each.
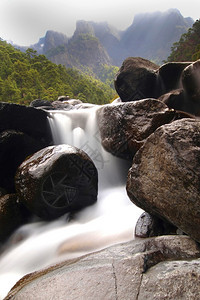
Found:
[0,107,142,299]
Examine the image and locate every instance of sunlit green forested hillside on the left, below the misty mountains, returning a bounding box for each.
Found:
[0,40,115,105]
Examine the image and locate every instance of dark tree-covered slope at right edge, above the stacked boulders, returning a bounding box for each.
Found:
[167,20,200,61]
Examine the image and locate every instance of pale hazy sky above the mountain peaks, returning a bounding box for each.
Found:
[0,0,200,46]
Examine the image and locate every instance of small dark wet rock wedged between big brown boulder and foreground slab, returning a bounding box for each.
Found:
[135,212,177,238]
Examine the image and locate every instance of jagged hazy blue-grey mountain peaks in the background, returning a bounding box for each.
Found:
[16,9,194,73]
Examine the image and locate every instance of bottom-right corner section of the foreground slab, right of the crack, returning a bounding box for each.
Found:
[138,259,200,300]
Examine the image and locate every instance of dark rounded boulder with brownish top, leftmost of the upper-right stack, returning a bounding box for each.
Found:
[114,57,159,102]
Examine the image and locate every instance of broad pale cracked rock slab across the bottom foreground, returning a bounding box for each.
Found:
[5,236,200,300]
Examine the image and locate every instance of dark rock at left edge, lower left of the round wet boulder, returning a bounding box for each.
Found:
[0,194,30,242]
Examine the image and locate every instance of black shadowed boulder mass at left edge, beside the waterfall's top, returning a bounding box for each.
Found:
[0,102,52,193]
